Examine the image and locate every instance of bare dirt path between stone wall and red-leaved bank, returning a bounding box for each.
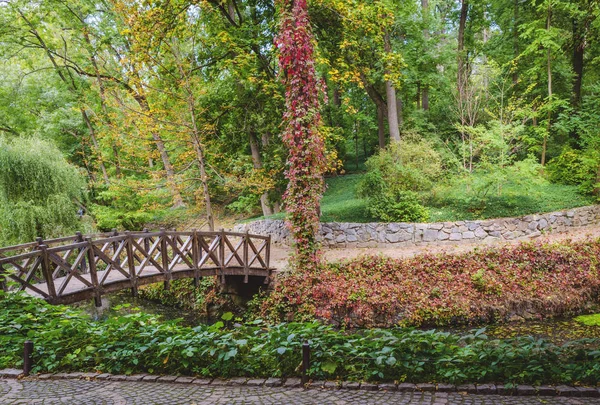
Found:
[271,225,600,271]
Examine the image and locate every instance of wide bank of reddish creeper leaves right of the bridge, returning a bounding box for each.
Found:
[262,239,600,327]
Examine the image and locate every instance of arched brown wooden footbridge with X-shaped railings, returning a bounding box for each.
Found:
[0,229,273,306]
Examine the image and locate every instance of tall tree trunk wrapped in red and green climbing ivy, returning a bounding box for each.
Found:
[275,0,325,271]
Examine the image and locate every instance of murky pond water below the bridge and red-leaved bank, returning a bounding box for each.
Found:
[74,292,600,344]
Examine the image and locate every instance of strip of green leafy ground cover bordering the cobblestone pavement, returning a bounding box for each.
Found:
[0,294,600,384]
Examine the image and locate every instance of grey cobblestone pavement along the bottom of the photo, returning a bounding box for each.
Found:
[0,380,600,405]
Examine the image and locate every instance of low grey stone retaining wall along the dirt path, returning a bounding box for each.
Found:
[233,205,600,248]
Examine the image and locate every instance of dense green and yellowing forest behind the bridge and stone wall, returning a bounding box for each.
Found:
[0,0,600,244]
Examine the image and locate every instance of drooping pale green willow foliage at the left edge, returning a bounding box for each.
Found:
[0,137,89,245]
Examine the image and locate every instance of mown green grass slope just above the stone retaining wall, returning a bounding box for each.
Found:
[244,174,594,222]
